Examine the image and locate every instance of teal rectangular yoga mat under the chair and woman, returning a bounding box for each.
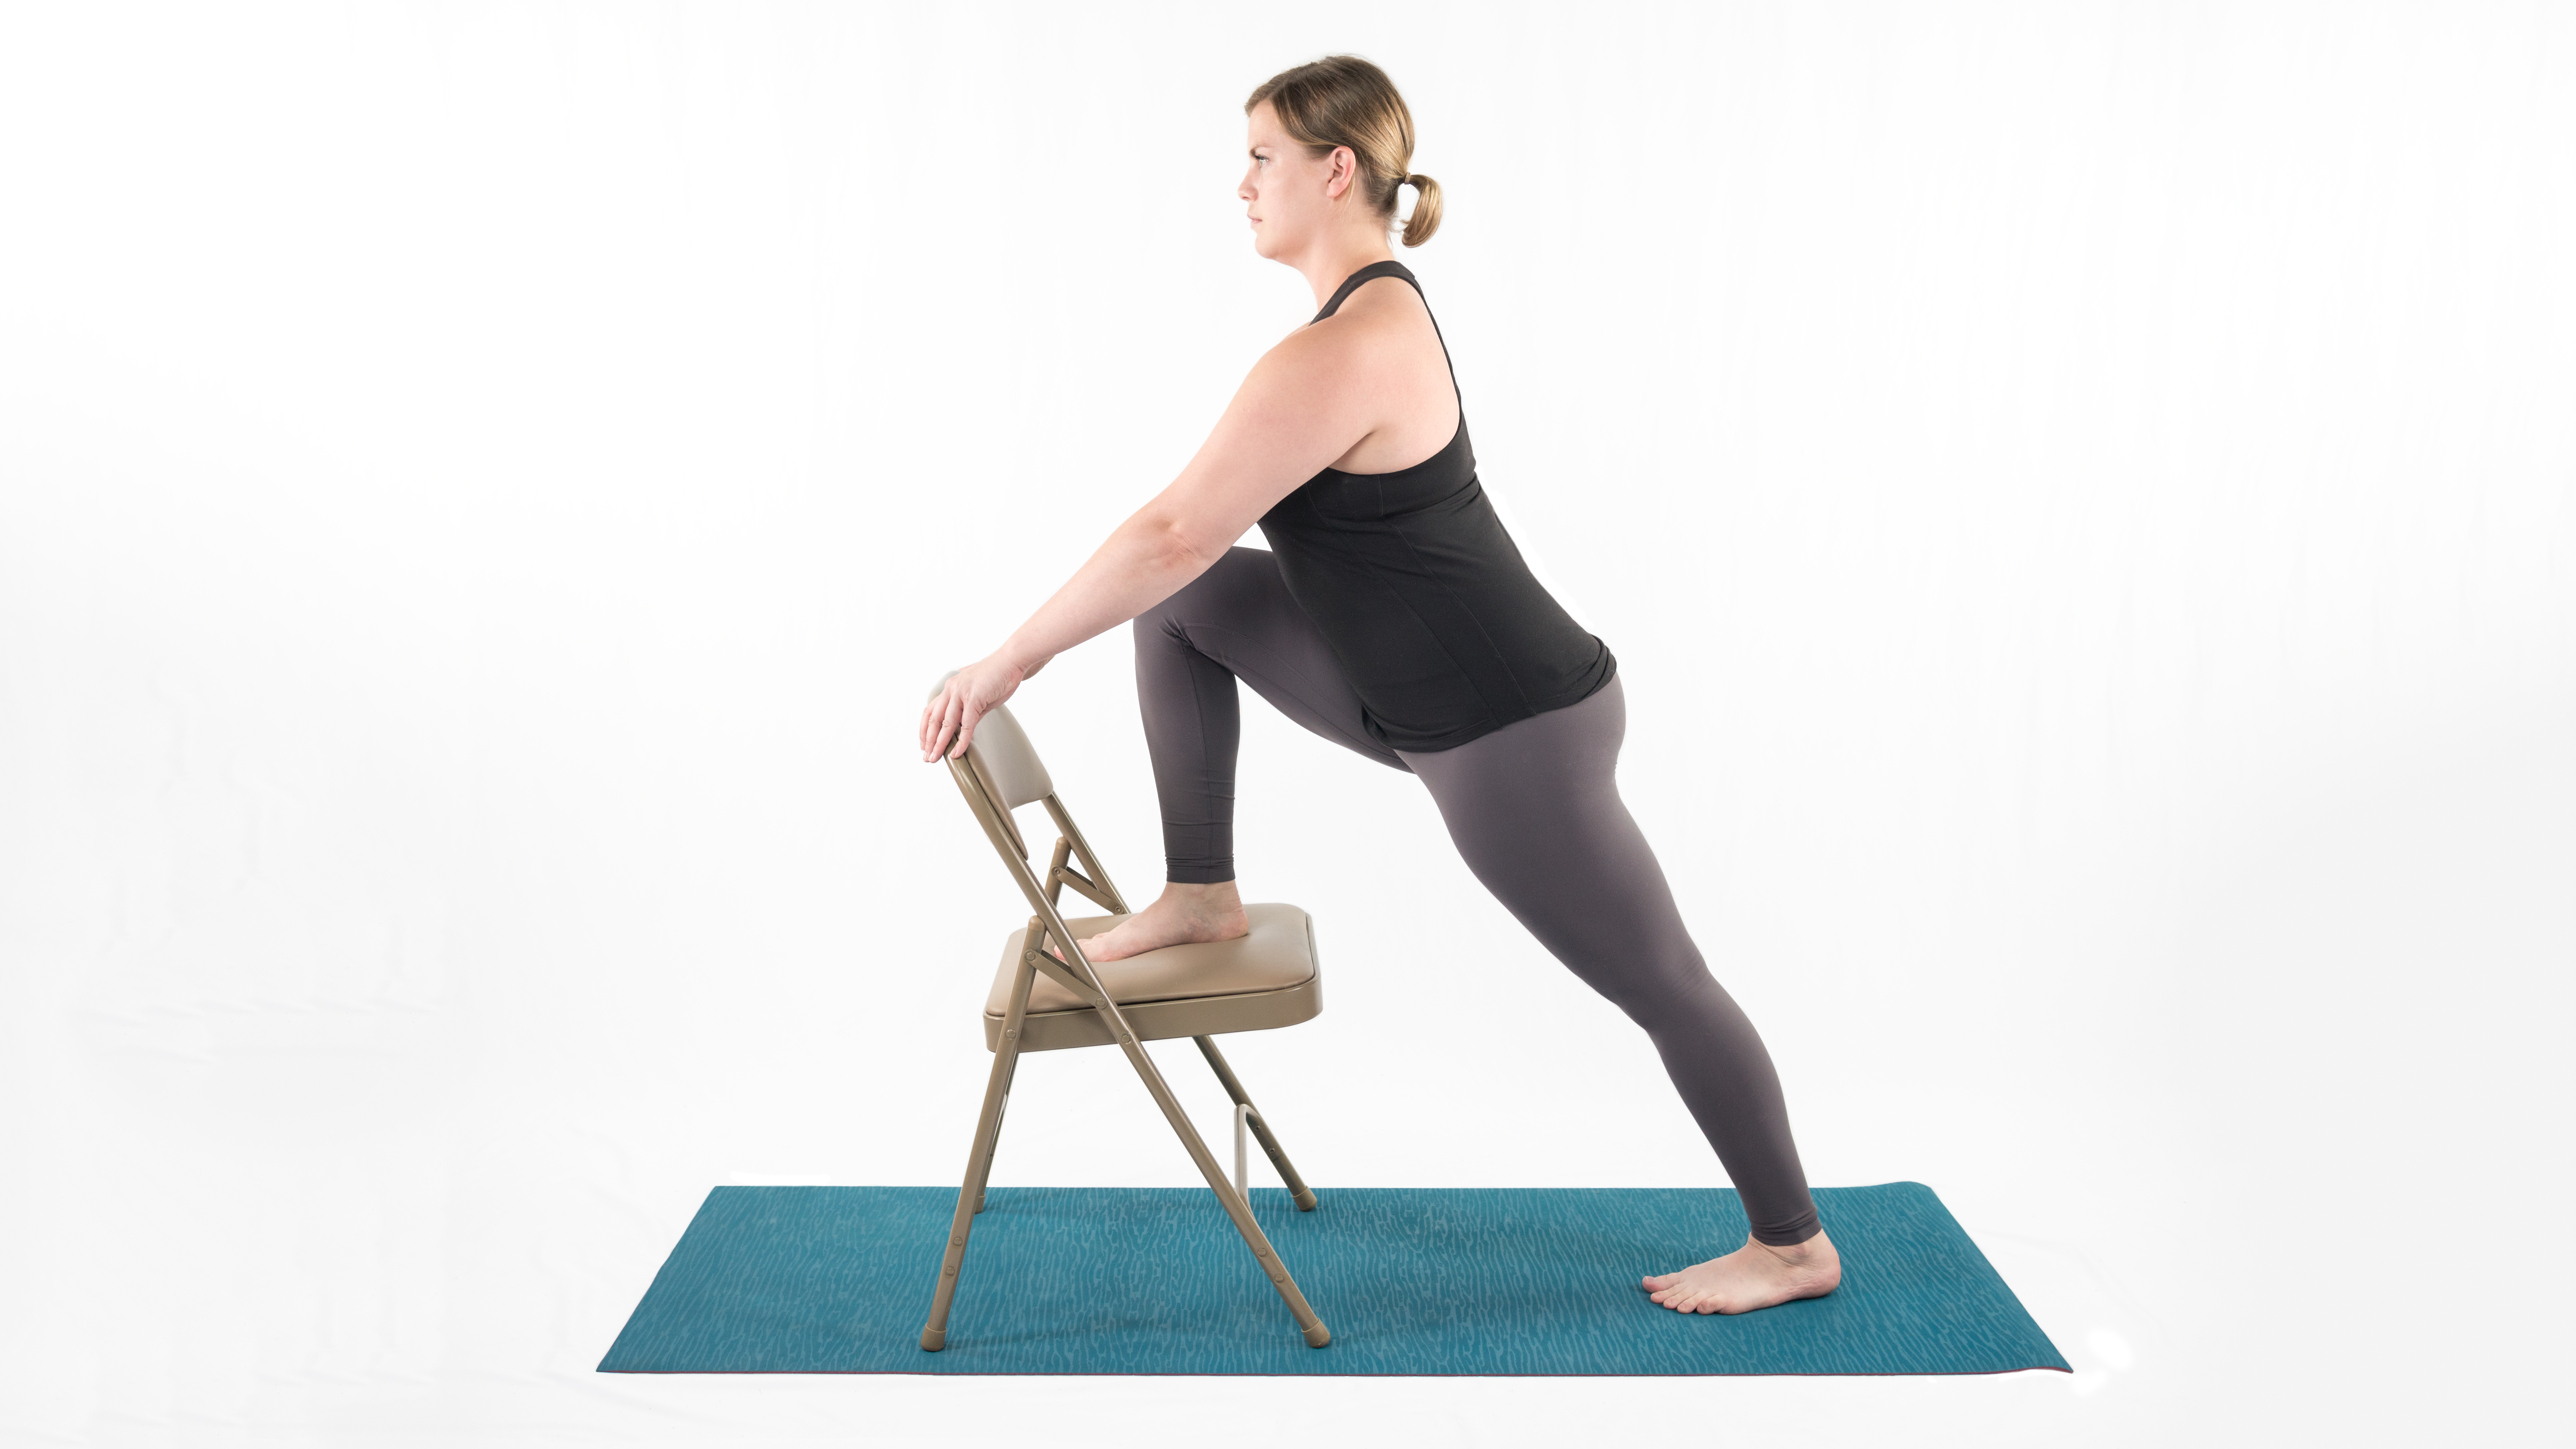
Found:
[600,1184,2071,1374]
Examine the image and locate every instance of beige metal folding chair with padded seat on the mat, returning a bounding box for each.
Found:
[922,678,1332,1351]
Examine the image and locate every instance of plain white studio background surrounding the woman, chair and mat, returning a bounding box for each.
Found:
[0,3,2576,1446]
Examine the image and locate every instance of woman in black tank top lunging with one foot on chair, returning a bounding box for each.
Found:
[922,57,1842,1312]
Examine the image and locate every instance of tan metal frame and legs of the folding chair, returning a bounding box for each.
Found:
[922,707,1332,1351]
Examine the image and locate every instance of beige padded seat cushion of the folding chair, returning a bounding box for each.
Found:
[984,902,1321,1052]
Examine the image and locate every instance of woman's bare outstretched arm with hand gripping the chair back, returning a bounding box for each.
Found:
[922,327,1394,761]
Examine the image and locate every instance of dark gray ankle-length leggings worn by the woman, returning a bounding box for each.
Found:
[1136,549,1821,1245]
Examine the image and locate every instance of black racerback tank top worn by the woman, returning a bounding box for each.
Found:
[1262,261,1618,753]
